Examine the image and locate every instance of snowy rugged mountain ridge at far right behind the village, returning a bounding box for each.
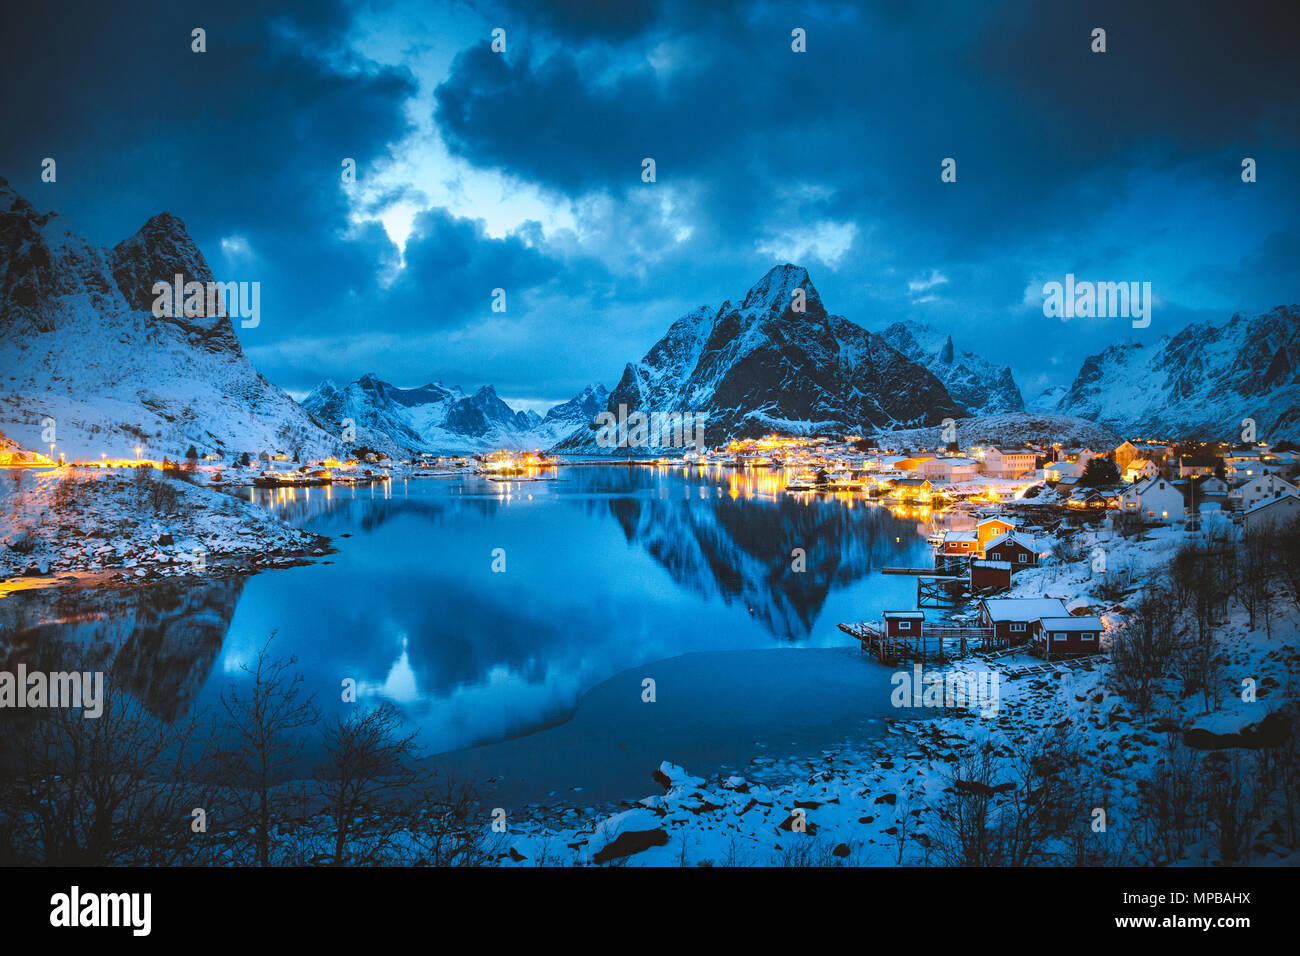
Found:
[1057,306,1300,441]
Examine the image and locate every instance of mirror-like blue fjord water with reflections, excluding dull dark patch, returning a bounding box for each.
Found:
[0,466,928,790]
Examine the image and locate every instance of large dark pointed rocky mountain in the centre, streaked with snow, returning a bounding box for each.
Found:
[559,264,965,451]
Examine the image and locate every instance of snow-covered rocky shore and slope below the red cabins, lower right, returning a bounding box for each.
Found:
[488,527,1300,866]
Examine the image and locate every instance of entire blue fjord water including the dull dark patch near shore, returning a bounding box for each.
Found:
[5,466,930,803]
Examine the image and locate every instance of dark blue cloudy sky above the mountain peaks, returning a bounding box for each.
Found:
[0,0,1300,406]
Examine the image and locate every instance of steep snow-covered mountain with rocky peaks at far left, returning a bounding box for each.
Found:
[0,179,338,460]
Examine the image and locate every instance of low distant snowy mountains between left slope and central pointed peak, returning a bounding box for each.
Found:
[303,375,608,455]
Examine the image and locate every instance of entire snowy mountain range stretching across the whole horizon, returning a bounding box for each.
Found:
[0,179,1300,459]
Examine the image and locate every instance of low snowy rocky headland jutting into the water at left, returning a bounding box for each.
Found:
[0,468,329,580]
